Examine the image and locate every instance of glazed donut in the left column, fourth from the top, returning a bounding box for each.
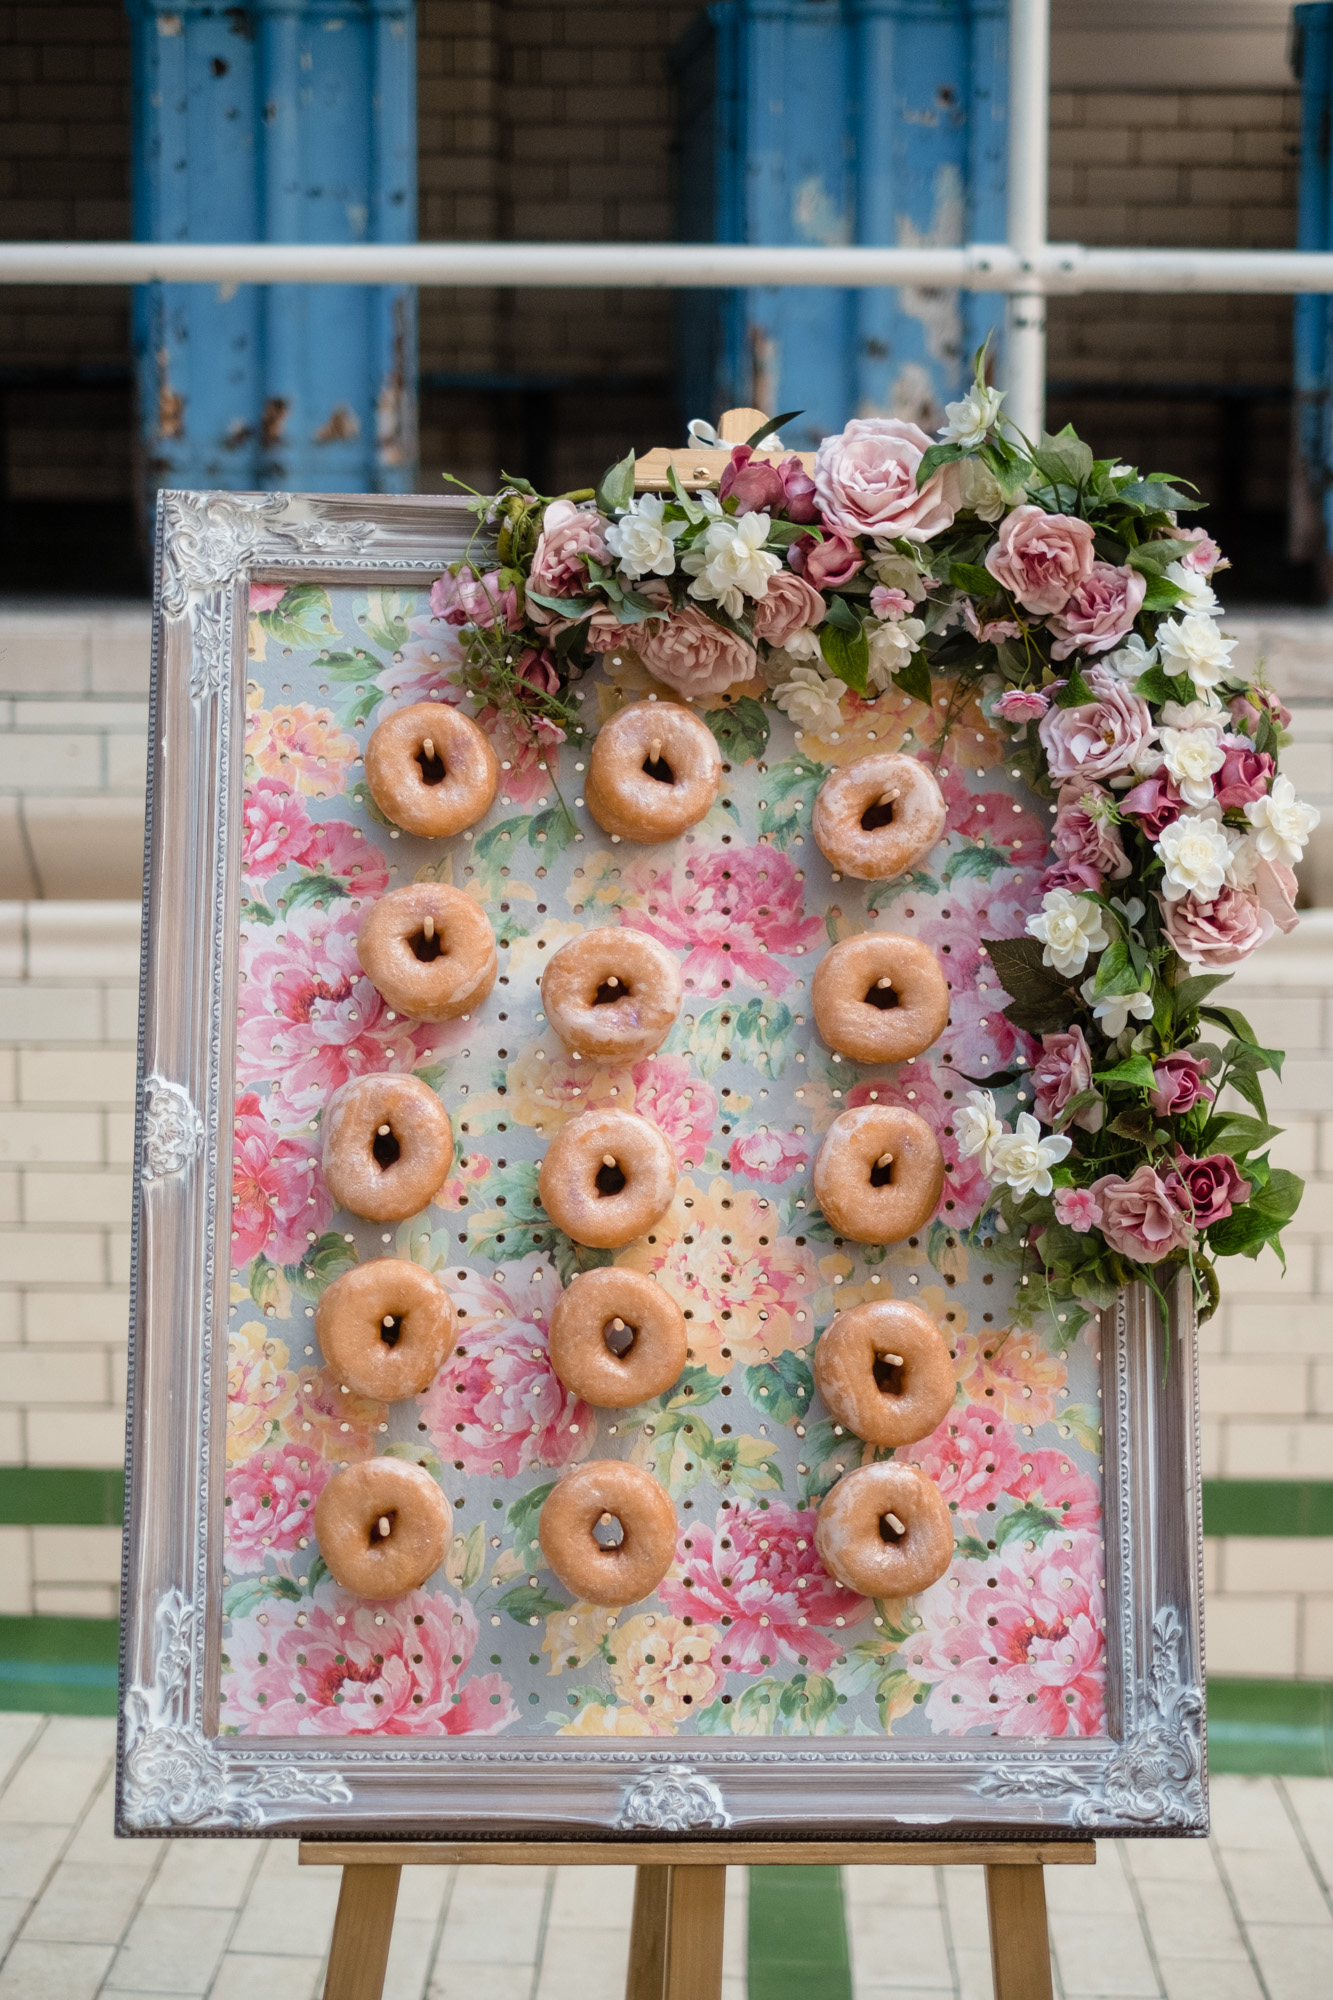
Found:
[314,1256,458,1402]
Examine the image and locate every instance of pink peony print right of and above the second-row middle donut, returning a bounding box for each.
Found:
[620,848,825,1000]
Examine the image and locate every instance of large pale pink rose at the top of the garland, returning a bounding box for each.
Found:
[815,416,956,542]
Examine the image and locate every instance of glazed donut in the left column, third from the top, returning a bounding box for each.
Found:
[324,1076,454,1222]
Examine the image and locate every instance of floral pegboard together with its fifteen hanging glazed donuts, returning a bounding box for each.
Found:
[223,582,1107,1748]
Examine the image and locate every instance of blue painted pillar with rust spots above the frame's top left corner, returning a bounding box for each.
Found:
[128,0,416,498]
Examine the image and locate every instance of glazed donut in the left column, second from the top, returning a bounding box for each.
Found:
[356,882,496,1020]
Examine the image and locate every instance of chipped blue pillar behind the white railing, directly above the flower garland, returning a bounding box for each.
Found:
[677,0,1009,448]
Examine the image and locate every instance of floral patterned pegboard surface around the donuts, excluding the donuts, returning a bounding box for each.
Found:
[220,584,1105,1740]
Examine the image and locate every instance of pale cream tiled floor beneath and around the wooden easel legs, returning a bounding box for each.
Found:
[0,1714,1333,2000]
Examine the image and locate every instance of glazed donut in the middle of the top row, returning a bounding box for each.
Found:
[584,702,723,846]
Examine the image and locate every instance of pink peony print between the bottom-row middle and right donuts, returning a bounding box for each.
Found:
[658,1500,871,1674]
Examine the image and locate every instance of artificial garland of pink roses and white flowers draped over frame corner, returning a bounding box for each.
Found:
[430,350,1319,1336]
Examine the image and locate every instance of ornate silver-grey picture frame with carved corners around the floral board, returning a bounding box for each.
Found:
[118,494,1207,1840]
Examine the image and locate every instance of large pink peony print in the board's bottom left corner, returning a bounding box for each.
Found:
[222,1584,518,1736]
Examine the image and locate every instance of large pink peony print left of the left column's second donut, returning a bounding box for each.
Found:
[236,904,466,1120]
